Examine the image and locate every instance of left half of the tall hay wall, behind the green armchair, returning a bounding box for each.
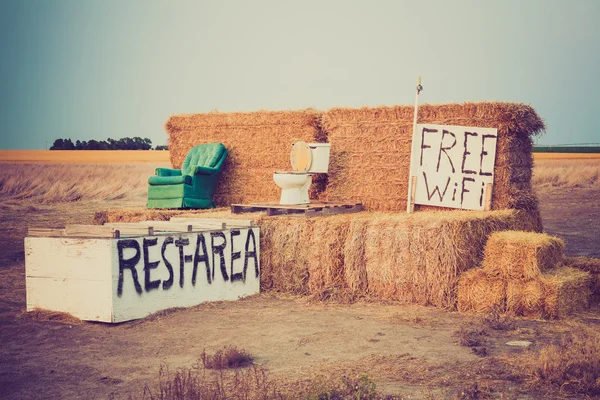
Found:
[165,110,326,207]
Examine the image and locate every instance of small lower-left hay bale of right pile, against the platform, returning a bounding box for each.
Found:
[458,268,506,313]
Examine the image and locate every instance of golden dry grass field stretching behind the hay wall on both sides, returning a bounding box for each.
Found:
[0,150,600,205]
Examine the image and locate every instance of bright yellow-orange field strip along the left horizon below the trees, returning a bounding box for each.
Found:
[0,150,169,164]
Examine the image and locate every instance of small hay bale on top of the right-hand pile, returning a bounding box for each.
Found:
[483,230,564,280]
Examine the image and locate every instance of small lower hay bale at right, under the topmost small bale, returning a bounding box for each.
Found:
[506,267,591,319]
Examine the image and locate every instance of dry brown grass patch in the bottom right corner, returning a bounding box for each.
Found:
[515,326,600,395]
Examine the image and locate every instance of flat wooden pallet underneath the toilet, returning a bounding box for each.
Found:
[231,202,363,217]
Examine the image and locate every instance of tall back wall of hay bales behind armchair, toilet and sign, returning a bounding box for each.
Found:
[165,102,545,231]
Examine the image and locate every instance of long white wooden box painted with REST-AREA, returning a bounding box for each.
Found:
[25,226,260,322]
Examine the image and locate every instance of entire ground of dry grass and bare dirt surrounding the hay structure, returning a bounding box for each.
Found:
[0,151,600,399]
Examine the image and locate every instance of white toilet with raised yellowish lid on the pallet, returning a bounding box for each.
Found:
[273,141,331,204]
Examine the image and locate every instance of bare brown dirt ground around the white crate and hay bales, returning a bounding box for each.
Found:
[0,189,600,399]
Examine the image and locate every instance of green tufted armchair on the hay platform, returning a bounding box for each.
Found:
[148,143,227,208]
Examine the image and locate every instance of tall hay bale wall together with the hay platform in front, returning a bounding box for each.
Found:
[95,103,562,309]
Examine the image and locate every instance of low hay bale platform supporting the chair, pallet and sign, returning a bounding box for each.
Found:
[96,209,535,309]
